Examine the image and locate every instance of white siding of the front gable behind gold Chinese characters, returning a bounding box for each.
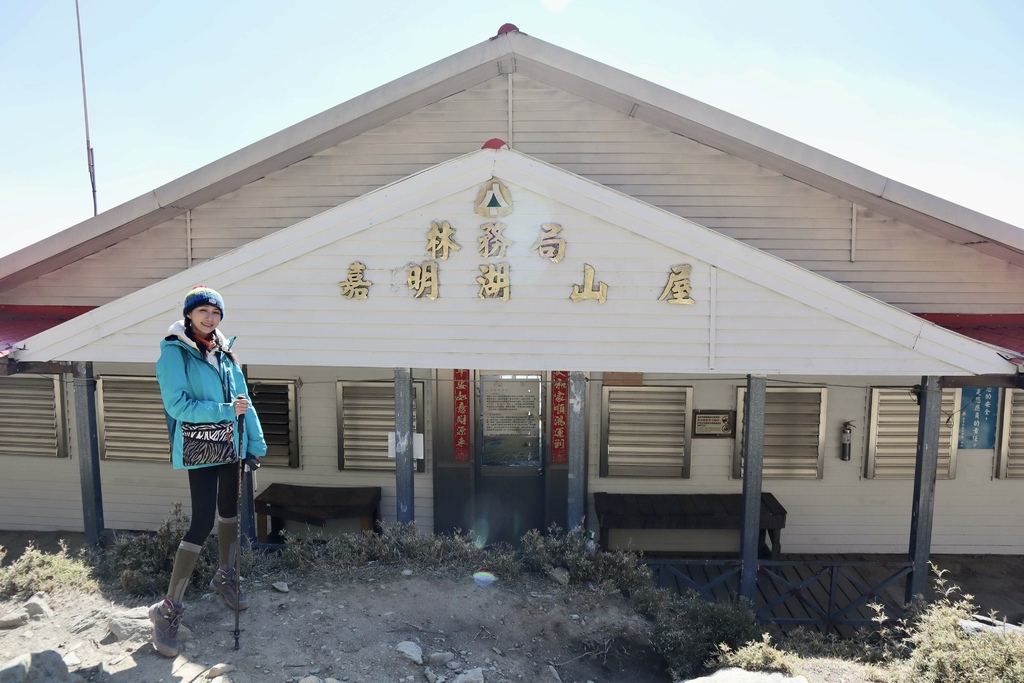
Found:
[48,179,983,375]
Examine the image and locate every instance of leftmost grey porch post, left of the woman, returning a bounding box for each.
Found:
[72,362,103,546]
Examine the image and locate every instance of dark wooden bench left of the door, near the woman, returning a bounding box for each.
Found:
[253,483,381,543]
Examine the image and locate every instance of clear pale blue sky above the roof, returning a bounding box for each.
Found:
[0,0,1024,256]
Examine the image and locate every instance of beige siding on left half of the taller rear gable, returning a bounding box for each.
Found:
[0,77,508,306]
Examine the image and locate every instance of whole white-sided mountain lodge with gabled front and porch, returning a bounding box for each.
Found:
[0,26,1024,565]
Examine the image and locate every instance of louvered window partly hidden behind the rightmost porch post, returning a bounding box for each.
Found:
[865,387,959,479]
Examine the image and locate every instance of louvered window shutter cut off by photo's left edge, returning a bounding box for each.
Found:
[0,375,68,458]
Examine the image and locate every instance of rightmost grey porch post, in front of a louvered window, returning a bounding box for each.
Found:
[906,377,942,603]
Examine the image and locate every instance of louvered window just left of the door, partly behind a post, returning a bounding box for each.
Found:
[338,382,424,472]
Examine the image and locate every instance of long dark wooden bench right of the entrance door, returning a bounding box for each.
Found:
[594,493,785,559]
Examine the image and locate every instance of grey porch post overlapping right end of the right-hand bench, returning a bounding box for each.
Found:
[739,375,767,602]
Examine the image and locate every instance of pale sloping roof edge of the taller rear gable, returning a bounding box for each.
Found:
[0,27,1024,292]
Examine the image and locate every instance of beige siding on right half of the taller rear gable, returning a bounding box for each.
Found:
[513,75,1024,313]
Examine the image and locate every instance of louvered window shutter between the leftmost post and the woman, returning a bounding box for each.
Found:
[96,375,171,462]
